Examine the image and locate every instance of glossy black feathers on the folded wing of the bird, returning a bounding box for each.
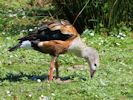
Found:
[19,25,73,42]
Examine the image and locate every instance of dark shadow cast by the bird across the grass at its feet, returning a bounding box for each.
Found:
[0,72,87,82]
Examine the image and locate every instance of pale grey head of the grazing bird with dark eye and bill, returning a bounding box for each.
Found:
[82,47,99,78]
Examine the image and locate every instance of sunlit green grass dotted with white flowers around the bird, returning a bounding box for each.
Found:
[0,1,133,100]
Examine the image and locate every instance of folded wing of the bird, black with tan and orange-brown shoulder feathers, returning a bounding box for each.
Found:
[19,20,78,42]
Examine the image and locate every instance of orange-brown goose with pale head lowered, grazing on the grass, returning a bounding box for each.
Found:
[9,19,99,81]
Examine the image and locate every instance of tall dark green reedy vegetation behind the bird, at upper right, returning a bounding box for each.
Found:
[53,0,133,33]
